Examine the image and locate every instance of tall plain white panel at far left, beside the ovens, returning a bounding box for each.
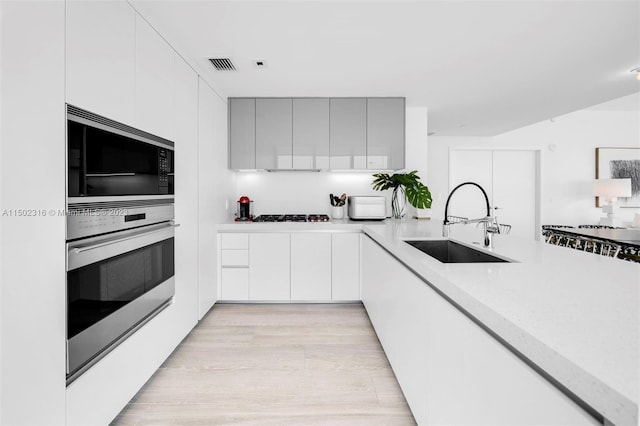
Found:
[0,1,66,425]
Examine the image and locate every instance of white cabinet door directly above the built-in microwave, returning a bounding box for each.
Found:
[66,0,136,126]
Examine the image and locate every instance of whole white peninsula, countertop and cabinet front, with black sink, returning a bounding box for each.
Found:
[361,220,640,425]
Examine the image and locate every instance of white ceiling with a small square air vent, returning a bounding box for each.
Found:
[130,0,640,136]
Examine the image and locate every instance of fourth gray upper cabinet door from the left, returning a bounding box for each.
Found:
[329,98,367,170]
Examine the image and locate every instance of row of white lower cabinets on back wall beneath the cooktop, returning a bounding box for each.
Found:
[220,231,360,302]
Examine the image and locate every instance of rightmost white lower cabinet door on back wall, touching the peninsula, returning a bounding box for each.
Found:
[331,233,360,300]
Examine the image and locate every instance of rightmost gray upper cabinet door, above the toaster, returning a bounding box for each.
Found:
[366,98,405,170]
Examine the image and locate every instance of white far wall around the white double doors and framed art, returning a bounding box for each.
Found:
[428,94,640,225]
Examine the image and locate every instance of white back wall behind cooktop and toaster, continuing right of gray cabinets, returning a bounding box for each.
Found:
[236,108,427,215]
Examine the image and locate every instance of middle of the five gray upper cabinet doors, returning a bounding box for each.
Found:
[293,98,329,170]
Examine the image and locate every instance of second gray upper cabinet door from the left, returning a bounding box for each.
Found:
[256,98,293,170]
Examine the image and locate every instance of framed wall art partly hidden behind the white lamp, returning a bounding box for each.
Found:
[596,148,640,208]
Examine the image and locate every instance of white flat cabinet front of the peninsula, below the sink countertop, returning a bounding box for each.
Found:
[362,237,600,426]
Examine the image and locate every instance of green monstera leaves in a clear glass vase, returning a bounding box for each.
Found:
[372,170,431,219]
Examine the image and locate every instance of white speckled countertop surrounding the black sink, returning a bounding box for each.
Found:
[363,220,640,425]
